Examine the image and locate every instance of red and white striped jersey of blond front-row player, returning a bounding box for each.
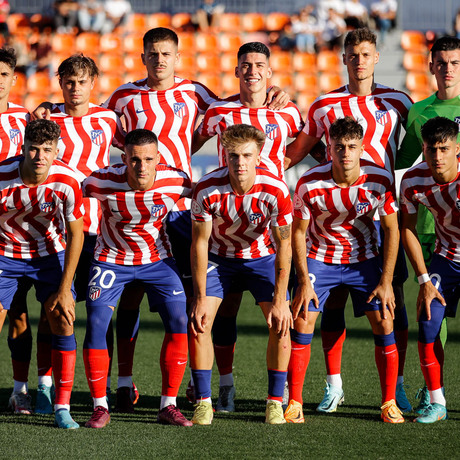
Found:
[192,167,292,259]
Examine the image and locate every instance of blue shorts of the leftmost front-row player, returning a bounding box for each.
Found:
[0,251,75,310]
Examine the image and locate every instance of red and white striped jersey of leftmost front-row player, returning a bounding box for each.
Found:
[0,155,83,259]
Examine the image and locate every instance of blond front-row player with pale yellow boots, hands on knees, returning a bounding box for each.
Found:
[189,125,293,425]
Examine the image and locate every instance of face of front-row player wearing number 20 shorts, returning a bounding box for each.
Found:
[121,144,160,191]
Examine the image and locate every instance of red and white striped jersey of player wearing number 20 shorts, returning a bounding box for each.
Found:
[83,164,192,265]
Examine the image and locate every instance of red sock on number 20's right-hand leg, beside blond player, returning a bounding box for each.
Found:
[160,333,188,397]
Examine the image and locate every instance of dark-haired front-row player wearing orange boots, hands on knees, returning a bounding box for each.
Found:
[285,117,404,423]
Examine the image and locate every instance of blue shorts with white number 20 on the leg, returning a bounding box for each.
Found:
[86,258,185,308]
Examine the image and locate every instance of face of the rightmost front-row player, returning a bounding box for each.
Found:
[423,139,460,182]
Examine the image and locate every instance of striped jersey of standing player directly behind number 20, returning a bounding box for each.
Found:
[103,77,218,178]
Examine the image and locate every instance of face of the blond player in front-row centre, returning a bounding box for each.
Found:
[225,141,260,189]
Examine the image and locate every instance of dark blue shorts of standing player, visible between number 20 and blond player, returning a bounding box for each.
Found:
[166,211,192,283]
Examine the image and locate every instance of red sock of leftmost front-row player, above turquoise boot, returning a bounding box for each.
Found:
[51,349,77,404]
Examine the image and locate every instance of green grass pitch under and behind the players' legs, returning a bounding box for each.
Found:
[0,260,460,460]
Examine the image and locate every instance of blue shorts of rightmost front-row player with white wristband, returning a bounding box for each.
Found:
[428,254,460,318]
